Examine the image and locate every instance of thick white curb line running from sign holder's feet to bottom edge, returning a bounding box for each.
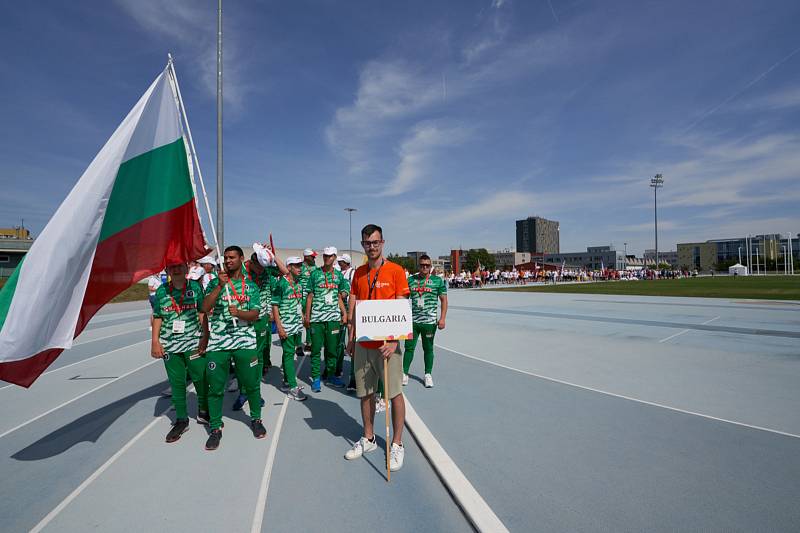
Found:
[406,397,508,532]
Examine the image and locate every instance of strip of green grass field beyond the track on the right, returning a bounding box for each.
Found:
[489,276,800,300]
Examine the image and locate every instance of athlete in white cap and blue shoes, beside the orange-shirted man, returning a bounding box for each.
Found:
[303,246,350,392]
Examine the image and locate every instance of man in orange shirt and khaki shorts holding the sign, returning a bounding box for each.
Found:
[345,224,409,472]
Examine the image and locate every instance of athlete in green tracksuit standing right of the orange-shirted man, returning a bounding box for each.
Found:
[403,255,447,388]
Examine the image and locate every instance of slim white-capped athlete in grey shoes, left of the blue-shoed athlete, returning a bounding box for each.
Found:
[272,257,306,401]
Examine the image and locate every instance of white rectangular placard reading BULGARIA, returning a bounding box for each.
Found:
[355,298,414,342]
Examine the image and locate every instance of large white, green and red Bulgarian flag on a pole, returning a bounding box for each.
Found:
[0,66,207,387]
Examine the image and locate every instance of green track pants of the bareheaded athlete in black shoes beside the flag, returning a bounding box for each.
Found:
[206,350,261,429]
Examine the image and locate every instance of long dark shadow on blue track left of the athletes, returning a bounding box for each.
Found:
[11,381,173,461]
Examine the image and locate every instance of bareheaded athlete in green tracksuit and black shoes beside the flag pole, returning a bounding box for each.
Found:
[203,246,267,450]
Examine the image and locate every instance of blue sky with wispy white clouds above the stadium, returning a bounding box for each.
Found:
[0,0,800,255]
